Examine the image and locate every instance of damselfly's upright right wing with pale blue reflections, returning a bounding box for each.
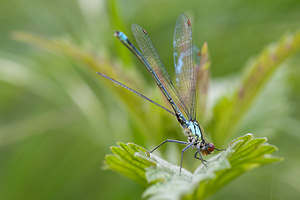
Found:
[173,15,196,120]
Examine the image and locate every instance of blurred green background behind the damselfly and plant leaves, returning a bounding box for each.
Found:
[0,0,300,200]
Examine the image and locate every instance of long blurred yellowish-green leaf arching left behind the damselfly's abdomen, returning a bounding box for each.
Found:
[13,32,157,143]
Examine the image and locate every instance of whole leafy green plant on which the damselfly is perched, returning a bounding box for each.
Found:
[14,23,300,199]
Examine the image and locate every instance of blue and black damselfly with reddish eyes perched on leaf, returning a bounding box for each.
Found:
[98,15,223,173]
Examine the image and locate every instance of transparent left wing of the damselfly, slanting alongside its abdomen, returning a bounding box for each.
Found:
[131,24,189,117]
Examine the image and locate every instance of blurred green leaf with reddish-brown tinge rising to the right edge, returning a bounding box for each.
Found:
[206,31,300,144]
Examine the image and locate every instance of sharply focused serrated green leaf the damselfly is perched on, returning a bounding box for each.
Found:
[106,134,282,200]
